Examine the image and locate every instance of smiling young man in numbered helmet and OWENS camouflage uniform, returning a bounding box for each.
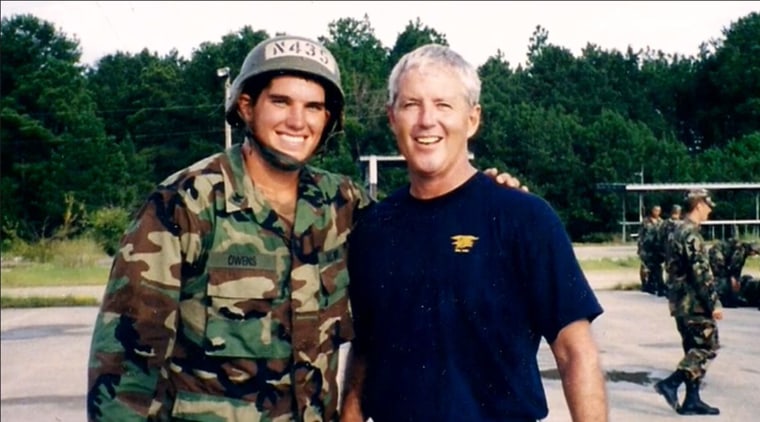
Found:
[87,36,519,421]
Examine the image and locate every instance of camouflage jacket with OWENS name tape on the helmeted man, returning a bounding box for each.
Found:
[87,145,370,421]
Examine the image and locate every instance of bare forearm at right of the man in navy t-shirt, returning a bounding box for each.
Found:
[552,321,608,422]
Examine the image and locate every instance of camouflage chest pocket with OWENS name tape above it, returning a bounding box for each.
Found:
[204,254,291,359]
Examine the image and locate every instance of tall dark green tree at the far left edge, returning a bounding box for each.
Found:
[0,15,136,238]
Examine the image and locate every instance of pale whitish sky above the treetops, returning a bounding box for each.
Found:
[0,1,760,68]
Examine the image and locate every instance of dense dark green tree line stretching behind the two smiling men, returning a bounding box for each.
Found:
[0,12,760,244]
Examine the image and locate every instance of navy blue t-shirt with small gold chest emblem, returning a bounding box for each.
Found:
[348,173,602,422]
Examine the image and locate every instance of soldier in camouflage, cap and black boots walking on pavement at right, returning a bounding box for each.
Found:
[654,189,723,415]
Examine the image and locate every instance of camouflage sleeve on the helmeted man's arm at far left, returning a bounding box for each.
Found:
[87,189,205,421]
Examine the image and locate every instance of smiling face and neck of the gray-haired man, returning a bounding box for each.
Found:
[388,66,480,190]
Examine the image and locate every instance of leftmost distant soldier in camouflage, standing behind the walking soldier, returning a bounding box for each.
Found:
[637,205,665,296]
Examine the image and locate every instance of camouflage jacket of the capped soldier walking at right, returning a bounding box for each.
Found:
[665,219,722,317]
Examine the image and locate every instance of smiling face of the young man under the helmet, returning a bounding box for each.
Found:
[238,76,330,161]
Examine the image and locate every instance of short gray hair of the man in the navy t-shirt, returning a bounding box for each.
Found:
[387,44,480,106]
